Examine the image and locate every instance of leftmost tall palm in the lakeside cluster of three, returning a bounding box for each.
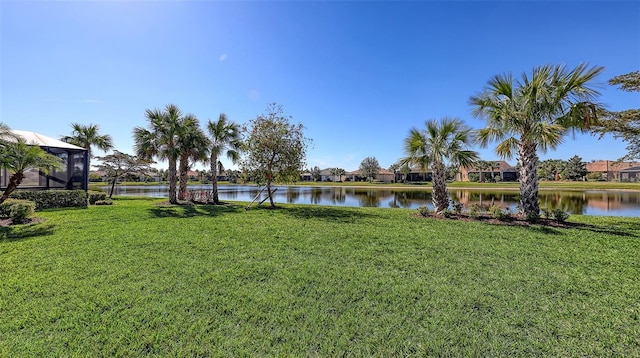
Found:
[133,104,184,204]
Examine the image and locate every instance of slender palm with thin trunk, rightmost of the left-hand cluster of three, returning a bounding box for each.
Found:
[207,113,242,204]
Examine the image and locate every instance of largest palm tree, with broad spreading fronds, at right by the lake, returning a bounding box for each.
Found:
[470,64,604,220]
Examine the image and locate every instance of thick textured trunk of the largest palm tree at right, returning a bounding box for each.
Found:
[518,141,540,219]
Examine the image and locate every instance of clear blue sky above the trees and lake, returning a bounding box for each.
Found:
[0,0,640,170]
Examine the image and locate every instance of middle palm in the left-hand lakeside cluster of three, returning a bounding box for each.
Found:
[178,114,209,200]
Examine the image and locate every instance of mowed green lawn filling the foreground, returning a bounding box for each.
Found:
[0,198,640,357]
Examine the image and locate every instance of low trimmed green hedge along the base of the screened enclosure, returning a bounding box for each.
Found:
[9,190,87,210]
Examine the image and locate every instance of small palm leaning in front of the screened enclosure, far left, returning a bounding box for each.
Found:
[0,137,62,203]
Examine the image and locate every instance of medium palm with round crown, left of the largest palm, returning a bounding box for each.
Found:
[402,118,478,213]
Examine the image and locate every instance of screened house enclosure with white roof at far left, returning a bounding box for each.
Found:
[0,130,89,190]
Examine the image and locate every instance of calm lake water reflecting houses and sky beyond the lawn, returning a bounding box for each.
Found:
[103,185,640,216]
